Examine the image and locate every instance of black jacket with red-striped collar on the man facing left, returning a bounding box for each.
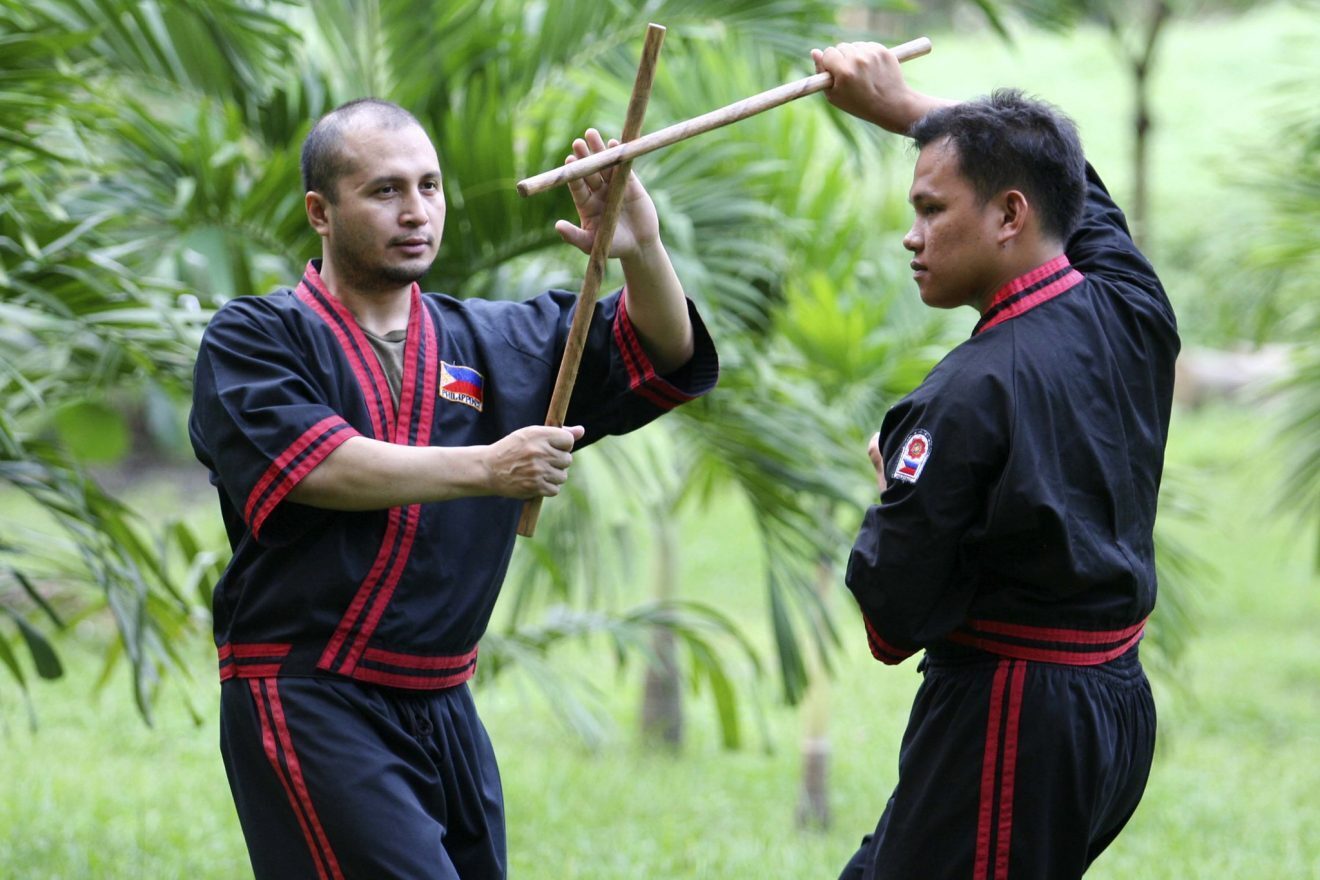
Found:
[847,168,1179,665]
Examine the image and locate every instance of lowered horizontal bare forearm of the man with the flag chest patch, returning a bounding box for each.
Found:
[288,437,492,511]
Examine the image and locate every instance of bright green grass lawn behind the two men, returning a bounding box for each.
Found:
[0,7,1320,880]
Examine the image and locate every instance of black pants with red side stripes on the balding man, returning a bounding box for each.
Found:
[220,678,507,880]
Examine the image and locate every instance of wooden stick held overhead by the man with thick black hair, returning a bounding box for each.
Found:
[517,37,931,195]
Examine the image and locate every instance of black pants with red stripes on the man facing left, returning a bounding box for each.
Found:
[840,648,1155,880]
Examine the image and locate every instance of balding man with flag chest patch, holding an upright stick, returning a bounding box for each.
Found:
[190,99,718,880]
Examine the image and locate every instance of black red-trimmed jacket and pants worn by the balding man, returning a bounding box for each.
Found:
[190,261,718,880]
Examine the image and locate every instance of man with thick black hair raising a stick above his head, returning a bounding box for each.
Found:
[812,44,1179,880]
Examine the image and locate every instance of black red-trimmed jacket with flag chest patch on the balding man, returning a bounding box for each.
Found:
[190,261,718,690]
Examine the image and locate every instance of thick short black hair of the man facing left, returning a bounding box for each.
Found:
[908,88,1086,241]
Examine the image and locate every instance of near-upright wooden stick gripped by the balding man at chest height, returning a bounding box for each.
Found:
[517,24,665,537]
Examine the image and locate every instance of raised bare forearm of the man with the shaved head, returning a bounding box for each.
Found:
[620,239,694,376]
